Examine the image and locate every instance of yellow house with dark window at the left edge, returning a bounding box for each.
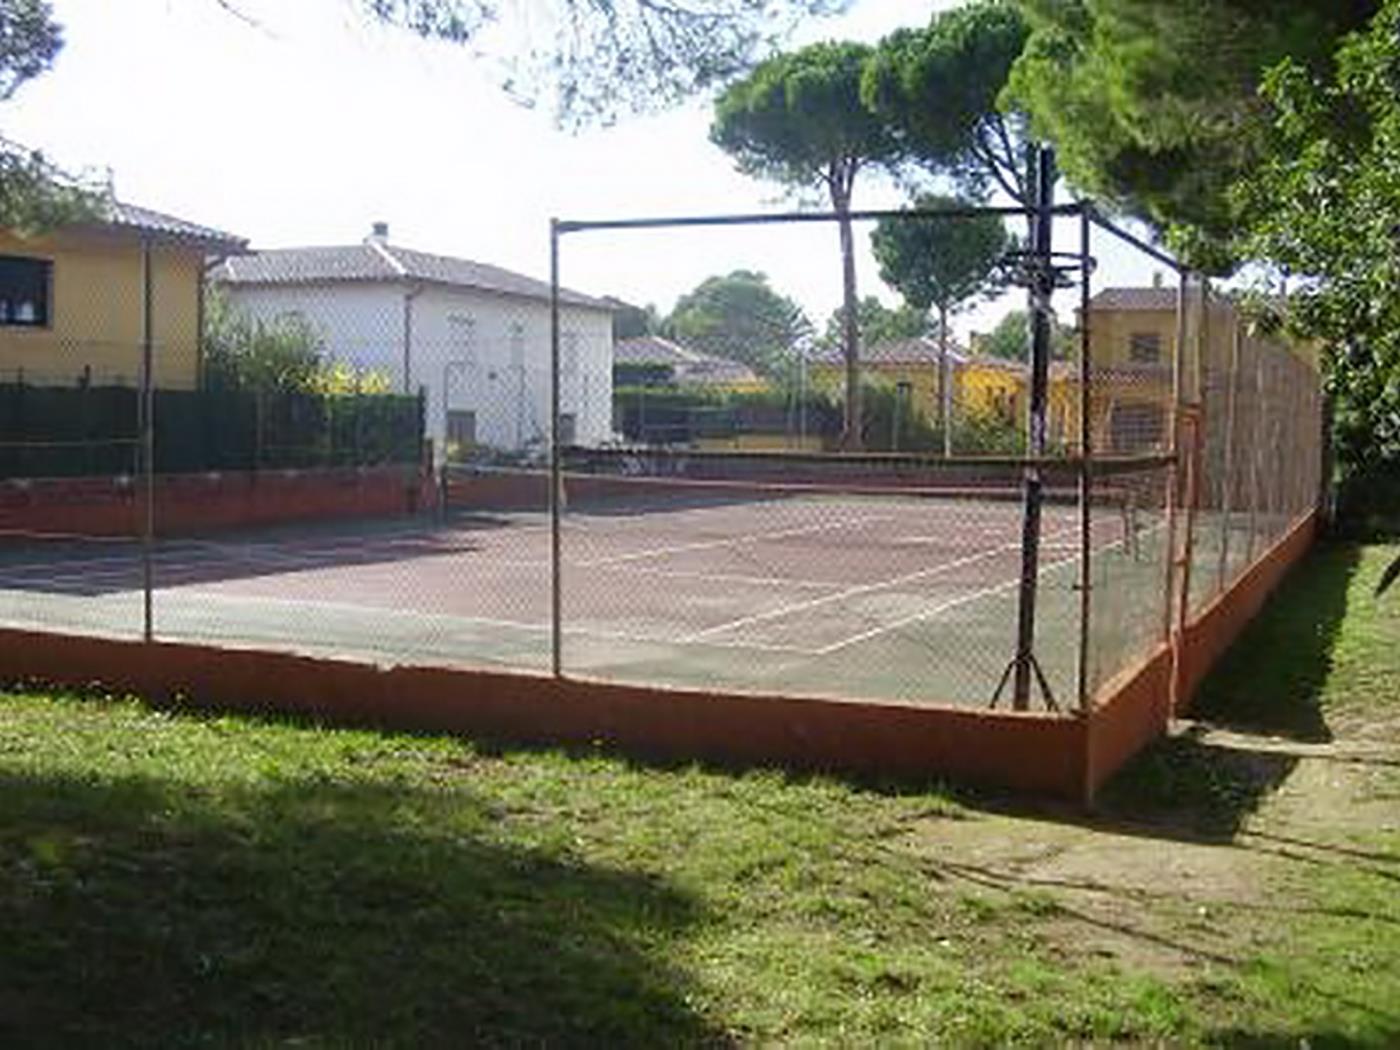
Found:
[0,202,246,389]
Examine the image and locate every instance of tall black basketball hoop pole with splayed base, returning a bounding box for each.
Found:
[1012,147,1056,711]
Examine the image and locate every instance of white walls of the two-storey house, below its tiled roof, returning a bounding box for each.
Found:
[225,281,612,449]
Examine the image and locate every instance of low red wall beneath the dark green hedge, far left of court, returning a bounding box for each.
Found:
[0,466,423,536]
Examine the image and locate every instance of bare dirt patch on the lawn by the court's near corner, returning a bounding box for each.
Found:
[906,725,1400,979]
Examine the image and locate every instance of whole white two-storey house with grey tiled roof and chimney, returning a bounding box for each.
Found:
[210,224,613,449]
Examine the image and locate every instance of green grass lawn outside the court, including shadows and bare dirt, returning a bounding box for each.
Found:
[0,546,1400,1047]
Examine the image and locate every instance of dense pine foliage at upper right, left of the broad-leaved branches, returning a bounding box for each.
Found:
[1007,0,1376,270]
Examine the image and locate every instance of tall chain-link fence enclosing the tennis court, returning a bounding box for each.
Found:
[0,198,1322,711]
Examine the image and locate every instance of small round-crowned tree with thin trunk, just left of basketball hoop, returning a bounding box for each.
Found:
[871,195,1012,455]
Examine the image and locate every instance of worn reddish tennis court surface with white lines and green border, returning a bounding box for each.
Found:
[0,496,1124,706]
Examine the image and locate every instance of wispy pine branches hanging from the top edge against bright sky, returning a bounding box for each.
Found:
[354,0,848,126]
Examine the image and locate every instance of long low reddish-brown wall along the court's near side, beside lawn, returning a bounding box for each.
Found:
[0,630,1085,799]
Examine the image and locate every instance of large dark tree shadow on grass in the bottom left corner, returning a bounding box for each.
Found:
[0,777,725,1046]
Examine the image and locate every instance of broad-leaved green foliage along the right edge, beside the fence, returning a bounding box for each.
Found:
[1236,0,1400,504]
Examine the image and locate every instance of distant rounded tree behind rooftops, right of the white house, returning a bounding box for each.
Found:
[661,270,812,375]
